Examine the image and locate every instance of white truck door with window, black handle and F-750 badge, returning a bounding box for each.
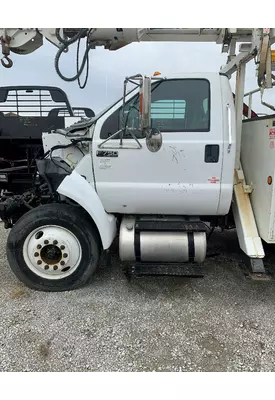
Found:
[93,74,229,215]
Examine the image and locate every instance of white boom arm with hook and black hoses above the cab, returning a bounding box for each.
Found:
[0,28,275,87]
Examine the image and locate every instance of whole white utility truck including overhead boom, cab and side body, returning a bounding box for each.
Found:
[0,28,275,291]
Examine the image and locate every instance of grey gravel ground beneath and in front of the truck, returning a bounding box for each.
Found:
[0,224,275,371]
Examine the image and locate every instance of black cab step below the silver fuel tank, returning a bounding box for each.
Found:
[124,263,204,279]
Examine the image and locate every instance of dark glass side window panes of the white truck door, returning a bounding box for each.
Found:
[100,79,210,139]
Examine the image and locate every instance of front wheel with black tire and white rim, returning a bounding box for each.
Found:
[7,204,101,292]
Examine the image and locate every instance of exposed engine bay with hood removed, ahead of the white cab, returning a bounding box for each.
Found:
[0,128,91,229]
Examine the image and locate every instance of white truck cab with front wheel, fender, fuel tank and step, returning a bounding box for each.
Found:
[3,73,239,290]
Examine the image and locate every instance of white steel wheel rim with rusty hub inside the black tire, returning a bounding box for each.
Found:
[23,226,82,279]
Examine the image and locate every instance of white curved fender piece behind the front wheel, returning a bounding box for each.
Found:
[57,171,117,249]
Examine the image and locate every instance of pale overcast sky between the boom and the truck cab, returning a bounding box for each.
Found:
[0,35,275,113]
